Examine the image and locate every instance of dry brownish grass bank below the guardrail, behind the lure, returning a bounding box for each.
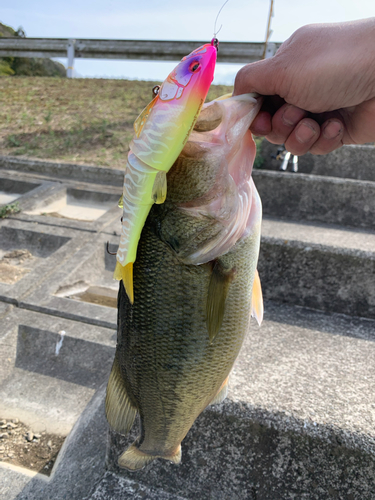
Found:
[0,77,232,168]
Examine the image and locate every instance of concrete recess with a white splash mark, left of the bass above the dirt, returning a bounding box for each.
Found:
[0,308,116,436]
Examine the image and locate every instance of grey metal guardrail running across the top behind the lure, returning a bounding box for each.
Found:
[0,37,281,77]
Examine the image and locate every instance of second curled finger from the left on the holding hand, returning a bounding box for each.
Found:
[267,104,307,144]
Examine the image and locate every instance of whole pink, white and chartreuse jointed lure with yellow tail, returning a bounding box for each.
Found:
[114,38,219,303]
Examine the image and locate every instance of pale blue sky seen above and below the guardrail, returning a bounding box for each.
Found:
[0,0,375,85]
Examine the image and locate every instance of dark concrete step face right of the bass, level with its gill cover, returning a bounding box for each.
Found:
[253,168,375,229]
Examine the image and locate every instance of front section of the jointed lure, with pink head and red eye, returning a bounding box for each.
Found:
[130,42,217,172]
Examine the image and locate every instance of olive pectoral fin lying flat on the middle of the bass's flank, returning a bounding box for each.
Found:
[206,260,236,342]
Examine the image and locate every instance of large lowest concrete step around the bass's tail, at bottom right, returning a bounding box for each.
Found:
[4,302,375,500]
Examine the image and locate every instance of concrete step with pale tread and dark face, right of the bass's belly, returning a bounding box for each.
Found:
[258,218,375,318]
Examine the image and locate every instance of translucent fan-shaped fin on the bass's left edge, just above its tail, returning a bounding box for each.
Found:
[105,357,137,434]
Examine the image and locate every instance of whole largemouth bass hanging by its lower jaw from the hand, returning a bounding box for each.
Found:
[106,90,263,470]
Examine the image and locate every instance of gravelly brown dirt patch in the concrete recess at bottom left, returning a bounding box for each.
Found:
[0,419,65,476]
